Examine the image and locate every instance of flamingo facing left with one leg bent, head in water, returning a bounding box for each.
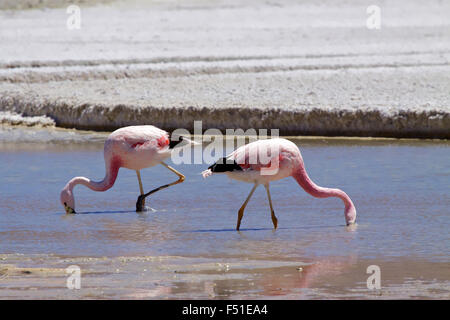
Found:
[60,125,195,213]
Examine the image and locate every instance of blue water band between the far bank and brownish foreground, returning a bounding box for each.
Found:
[0,139,450,262]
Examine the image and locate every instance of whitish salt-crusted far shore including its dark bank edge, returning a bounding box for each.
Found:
[0,0,450,138]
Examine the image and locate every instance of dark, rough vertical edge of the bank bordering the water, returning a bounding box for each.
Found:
[0,93,450,139]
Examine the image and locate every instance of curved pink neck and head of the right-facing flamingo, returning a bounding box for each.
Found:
[292,163,356,223]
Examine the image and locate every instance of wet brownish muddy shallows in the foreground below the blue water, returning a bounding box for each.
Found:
[0,254,449,299]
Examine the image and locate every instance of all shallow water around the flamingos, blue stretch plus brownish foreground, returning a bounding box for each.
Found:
[0,129,450,299]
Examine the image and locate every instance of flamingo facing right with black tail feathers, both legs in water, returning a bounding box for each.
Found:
[202,138,356,230]
